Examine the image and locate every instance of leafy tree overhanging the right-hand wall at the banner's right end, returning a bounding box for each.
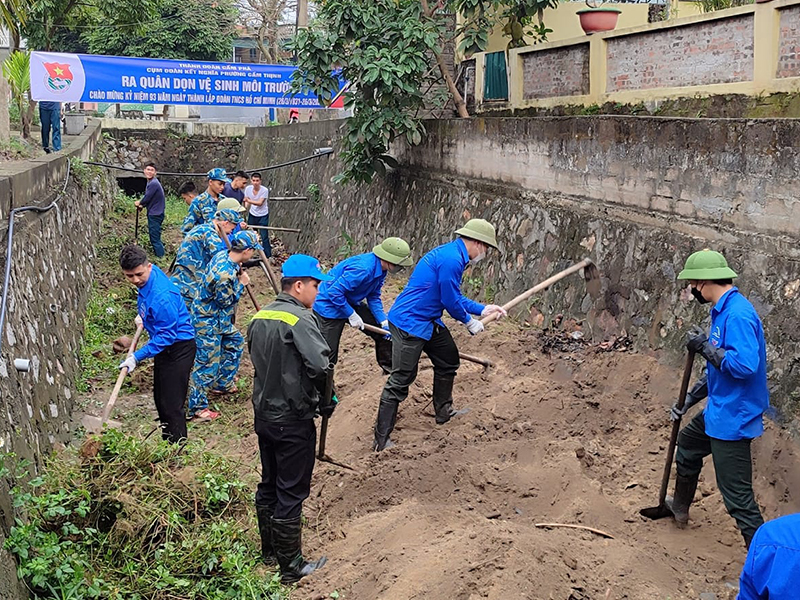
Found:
[292,0,558,182]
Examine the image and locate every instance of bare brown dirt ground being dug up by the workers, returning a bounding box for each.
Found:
[81,264,800,600]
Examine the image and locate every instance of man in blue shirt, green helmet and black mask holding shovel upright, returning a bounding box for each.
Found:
[668,249,769,547]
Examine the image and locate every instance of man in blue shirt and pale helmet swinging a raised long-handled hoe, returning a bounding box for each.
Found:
[373,219,505,452]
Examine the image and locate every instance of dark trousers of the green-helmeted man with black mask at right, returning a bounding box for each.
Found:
[675,412,764,541]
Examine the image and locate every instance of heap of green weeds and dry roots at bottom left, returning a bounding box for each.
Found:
[0,430,288,600]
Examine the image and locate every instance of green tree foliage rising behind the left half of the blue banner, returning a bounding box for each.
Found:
[86,0,238,61]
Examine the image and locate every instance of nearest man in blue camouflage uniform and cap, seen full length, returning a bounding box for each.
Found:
[189,231,262,421]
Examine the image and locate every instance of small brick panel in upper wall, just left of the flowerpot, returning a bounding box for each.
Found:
[522,44,589,100]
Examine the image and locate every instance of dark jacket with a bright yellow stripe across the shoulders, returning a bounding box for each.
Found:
[247,293,331,422]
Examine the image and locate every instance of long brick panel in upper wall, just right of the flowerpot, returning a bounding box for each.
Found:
[607,14,753,92]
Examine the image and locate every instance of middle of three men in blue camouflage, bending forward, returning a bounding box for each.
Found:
[170,208,242,312]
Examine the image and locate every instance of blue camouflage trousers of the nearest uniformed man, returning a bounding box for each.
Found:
[188,318,244,416]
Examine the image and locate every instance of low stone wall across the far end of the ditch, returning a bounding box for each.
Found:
[103,128,242,192]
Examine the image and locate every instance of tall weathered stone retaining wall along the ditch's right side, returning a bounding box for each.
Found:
[242,117,800,424]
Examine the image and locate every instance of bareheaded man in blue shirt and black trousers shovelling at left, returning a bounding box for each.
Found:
[119,245,196,443]
